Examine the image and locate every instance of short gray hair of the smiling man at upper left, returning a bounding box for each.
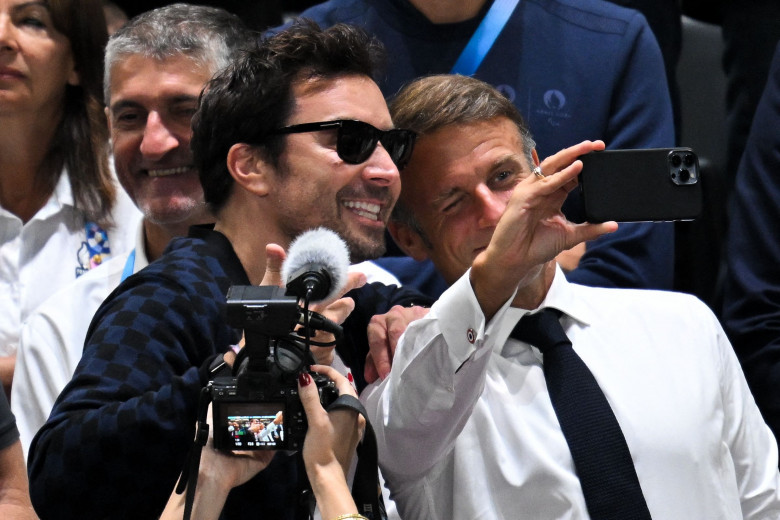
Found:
[103,4,250,104]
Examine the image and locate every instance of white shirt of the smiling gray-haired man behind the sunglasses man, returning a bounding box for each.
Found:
[11,222,149,458]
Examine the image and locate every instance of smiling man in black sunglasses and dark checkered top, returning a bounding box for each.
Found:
[31,20,430,520]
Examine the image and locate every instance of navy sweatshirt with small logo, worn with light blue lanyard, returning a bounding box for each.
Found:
[280,0,674,289]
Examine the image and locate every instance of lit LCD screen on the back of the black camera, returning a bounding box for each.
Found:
[214,402,284,450]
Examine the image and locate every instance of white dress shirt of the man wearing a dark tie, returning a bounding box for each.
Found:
[362,269,780,520]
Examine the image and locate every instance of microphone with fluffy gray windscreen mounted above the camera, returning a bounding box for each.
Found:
[282,227,349,302]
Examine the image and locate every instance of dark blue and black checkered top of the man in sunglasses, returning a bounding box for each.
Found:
[29,228,425,520]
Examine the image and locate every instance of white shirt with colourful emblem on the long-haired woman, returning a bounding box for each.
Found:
[0,172,140,356]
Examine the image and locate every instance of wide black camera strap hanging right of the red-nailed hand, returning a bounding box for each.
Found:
[328,394,387,520]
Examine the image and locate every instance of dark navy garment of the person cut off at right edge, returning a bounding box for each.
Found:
[723,45,780,450]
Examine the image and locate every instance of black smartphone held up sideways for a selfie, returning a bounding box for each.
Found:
[579,148,702,222]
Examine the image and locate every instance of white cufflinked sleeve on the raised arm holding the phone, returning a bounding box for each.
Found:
[361,272,511,475]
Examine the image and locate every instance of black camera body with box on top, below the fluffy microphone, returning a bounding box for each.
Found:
[210,286,338,451]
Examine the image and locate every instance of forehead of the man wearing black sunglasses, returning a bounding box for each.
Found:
[287,75,392,129]
